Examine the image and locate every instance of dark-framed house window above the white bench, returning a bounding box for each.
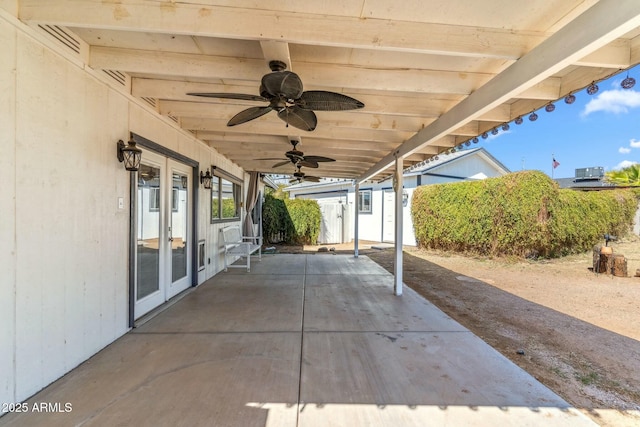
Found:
[211,166,242,221]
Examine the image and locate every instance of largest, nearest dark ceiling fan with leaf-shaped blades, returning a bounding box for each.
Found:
[187,61,364,131]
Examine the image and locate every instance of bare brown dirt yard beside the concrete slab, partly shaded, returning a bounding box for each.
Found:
[276,238,640,426]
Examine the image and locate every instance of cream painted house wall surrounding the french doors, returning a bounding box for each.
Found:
[0,7,247,402]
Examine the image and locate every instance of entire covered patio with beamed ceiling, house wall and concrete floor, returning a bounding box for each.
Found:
[0,0,640,426]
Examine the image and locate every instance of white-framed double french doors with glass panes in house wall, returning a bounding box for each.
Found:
[134,150,193,319]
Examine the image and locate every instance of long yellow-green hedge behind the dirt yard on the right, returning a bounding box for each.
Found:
[411,171,637,257]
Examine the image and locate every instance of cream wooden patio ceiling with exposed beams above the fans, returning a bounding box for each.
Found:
[13,0,640,181]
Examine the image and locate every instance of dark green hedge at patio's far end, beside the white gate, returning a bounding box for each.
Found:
[262,194,322,244]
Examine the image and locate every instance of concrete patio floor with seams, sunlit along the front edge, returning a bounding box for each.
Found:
[0,254,595,427]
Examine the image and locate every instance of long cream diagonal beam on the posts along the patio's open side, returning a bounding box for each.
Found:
[357,0,640,182]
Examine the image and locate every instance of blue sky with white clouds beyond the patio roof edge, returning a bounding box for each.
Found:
[471,66,640,178]
